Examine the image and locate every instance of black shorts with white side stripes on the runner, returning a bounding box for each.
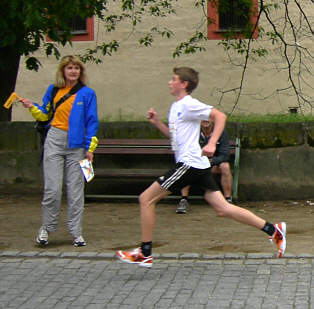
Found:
[157,162,219,192]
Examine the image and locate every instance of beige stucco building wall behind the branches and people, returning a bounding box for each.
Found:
[13,0,314,121]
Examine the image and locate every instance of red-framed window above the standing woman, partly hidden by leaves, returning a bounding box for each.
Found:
[46,16,94,42]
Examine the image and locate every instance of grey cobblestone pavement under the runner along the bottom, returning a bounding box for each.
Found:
[0,251,314,309]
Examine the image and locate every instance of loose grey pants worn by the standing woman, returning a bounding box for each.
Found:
[41,127,85,238]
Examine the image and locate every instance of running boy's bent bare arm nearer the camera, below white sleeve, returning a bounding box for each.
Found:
[202,108,227,157]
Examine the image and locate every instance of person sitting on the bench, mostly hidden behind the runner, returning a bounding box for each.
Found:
[176,120,232,214]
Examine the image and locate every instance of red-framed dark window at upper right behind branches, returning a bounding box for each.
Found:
[207,0,257,40]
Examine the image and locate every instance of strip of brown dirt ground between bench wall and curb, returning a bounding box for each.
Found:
[0,196,314,254]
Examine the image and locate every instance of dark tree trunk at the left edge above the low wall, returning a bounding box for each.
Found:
[0,46,20,121]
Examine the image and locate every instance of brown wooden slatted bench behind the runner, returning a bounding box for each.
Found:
[86,138,240,200]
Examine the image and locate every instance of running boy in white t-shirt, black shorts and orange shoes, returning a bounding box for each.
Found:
[116,67,286,267]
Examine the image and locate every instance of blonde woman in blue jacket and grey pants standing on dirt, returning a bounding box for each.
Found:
[20,55,98,246]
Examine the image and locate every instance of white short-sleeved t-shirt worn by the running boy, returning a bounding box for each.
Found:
[168,95,213,169]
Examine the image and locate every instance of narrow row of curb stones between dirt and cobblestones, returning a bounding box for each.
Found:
[0,250,314,261]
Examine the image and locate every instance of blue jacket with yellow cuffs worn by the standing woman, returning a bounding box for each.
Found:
[29,85,98,152]
